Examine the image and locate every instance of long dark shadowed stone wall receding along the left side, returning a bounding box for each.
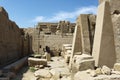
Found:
[0,7,32,67]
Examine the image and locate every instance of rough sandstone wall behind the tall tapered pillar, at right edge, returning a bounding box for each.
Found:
[99,0,120,62]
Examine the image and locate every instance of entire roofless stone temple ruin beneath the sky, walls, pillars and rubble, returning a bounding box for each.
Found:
[0,0,120,80]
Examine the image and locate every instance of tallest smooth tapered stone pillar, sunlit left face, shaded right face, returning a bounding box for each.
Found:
[92,2,116,68]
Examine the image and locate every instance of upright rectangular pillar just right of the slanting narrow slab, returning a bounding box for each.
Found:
[77,14,91,54]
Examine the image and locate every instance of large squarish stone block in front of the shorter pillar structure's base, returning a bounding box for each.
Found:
[72,54,95,71]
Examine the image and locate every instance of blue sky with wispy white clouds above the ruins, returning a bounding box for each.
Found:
[0,0,98,28]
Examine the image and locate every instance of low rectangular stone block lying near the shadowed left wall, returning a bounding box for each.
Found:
[28,58,47,67]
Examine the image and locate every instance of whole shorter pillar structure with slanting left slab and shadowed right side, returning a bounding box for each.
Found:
[69,14,96,67]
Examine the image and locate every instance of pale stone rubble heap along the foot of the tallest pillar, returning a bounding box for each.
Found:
[74,63,120,80]
